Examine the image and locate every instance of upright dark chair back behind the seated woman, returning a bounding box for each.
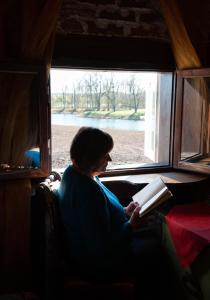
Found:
[31,172,63,300]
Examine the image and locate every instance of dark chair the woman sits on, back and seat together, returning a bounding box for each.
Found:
[32,172,134,300]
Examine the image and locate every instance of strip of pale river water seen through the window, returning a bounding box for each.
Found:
[51,113,144,131]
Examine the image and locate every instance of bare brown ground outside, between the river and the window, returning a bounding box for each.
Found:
[52,125,151,168]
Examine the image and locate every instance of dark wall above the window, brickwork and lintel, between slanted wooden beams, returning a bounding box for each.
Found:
[53,0,174,69]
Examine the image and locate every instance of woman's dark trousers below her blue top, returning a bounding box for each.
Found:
[67,226,174,300]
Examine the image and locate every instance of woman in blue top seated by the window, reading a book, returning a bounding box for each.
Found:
[58,127,176,299]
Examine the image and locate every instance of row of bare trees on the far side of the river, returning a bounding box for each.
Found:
[51,72,145,113]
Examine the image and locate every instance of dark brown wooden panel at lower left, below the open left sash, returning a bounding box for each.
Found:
[0,179,31,292]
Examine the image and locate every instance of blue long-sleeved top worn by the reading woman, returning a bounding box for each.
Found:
[58,166,131,260]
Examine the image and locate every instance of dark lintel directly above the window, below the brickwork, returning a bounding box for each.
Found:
[52,35,175,70]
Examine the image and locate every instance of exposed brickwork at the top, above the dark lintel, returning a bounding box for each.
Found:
[57,0,168,41]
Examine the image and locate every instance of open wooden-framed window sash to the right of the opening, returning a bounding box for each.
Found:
[174,68,210,174]
